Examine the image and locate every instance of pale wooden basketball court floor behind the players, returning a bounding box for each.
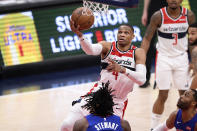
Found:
[0,74,178,131]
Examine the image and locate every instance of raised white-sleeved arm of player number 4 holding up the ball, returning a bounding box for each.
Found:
[70,20,109,55]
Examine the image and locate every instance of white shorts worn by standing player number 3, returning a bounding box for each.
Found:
[155,52,189,90]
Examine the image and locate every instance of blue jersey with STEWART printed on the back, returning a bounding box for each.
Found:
[86,114,123,131]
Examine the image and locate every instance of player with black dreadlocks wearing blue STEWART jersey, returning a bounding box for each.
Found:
[73,82,131,131]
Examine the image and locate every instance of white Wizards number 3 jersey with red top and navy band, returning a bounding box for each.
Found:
[157,7,189,56]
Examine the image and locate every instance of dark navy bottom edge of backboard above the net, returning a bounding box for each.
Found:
[89,0,138,8]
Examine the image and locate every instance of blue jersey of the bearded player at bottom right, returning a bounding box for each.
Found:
[174,109,197,131]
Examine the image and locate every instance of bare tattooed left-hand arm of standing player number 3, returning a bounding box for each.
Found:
[141,11,161,54]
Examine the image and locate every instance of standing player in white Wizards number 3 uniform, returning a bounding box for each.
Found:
[141,0,195,128]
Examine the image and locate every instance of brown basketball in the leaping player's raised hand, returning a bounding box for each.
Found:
[71,7,94,30]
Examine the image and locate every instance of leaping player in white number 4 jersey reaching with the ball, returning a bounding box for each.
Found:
[61,20,146,131]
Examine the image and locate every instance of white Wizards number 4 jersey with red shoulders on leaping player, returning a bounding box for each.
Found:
[100,42,137,102]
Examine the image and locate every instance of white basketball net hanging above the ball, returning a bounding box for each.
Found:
[82,0,109,15]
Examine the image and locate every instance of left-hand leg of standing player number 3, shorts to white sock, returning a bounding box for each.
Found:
[151,54,172,128]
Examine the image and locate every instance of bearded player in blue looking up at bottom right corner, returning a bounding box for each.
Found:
[153,89,197,131]
